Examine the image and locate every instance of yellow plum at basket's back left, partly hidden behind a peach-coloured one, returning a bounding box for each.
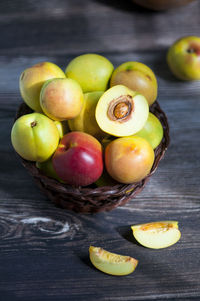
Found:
[19,62,66,112]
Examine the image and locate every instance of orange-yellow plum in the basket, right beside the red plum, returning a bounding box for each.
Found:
[105,136,154,184]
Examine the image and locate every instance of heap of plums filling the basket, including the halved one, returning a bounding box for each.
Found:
[11,54,166,186]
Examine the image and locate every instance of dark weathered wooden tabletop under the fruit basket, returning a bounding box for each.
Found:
[0,0,200,301]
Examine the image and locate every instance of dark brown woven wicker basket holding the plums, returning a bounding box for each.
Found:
[16,102,170,213]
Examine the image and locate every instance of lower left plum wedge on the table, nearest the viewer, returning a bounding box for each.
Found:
[89,246,138,276]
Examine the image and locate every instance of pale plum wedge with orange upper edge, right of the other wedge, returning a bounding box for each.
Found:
[131,221,181,249]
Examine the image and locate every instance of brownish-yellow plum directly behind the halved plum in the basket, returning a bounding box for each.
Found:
[110,62,158,105]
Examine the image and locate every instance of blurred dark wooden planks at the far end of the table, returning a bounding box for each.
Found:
[0,0,200,55]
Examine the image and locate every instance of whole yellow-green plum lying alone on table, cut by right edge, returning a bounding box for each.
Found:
[167,36,200,80]
